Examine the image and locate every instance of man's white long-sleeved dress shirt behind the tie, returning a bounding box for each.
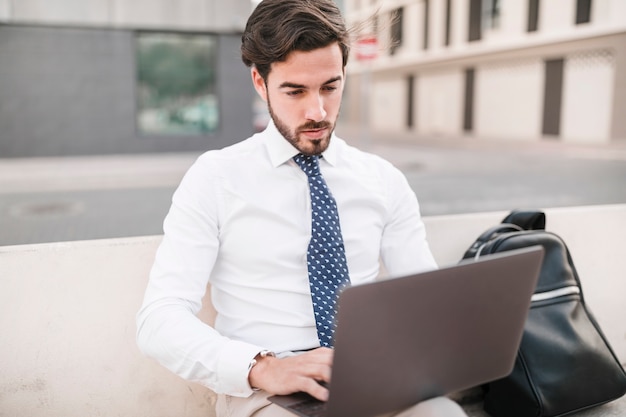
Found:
[137,123,436,396]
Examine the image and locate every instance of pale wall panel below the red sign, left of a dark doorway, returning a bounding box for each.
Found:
[369,77,407,131]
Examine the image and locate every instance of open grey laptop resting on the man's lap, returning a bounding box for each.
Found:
[270,246,544,417]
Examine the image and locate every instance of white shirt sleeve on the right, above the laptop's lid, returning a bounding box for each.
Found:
[381,168,437,278]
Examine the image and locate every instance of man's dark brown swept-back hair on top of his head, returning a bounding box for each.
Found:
[241,0,350,80]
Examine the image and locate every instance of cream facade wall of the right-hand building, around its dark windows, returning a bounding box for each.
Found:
[345,0,626,145]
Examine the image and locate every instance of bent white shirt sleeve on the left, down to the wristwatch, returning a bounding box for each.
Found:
[137,156,263,397]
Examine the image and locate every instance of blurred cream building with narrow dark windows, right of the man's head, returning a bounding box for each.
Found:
[344,0,626,143]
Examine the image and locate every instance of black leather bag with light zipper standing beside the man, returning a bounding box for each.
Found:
[463,210,626,417]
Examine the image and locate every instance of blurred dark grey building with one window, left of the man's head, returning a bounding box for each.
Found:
[0,0,255,157]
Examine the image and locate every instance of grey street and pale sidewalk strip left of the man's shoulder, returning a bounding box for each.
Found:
[0,153,197,245]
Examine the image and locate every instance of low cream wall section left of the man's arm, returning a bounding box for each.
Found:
[0,237,214,417]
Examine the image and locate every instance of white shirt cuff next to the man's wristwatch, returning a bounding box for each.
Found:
[218,340,264,397]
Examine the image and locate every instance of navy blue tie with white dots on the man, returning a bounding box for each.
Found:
[293,154,350,347]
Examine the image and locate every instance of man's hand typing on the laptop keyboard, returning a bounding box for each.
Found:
[248,348,333,401]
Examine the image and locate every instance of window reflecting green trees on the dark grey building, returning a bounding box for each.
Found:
[136,33,219,135]
